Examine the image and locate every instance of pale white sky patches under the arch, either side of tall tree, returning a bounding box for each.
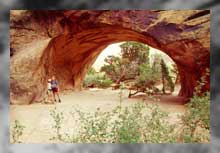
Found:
[92,42,173,71]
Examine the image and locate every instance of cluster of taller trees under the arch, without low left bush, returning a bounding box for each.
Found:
[101,41,174,93]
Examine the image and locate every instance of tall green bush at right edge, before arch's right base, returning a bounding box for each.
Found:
[181,70,210,143]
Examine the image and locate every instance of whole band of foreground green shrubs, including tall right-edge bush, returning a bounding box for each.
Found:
[48,82,210,143]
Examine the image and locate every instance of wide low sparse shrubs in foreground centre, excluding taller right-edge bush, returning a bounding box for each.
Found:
[49,103,176,143]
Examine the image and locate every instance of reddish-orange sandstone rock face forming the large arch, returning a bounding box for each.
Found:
[10,10,210,104]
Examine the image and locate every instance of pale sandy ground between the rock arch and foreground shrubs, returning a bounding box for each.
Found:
[10,89,185,143]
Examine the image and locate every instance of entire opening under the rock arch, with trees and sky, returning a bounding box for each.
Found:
[83,41,181,97]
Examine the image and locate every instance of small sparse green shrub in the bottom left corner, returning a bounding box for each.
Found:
[11,120,25,143]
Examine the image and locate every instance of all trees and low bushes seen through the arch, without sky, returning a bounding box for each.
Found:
[84,41,178,97]
